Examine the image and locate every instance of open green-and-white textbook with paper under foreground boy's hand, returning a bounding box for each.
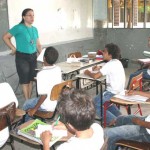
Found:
[17,119,67,146]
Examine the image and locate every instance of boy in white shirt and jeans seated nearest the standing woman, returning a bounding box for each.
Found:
[23,47,62,121]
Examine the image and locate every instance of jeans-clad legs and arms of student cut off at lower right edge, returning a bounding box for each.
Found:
[104,91,150,150]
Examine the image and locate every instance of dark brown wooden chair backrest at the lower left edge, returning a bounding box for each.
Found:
[0,102,16,131]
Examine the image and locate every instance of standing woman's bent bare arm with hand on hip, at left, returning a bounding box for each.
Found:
[3,32,16,55]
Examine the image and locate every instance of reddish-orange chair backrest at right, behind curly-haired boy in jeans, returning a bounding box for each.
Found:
[129,73,143,91]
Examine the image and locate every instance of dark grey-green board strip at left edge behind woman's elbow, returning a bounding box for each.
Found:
[0,0,9,52]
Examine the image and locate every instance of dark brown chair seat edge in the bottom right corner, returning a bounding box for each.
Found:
[116,140,150,150]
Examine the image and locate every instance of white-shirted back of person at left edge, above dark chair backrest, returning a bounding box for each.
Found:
[0,82,18,108]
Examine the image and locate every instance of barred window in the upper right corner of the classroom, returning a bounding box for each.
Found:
[107,0,150,29]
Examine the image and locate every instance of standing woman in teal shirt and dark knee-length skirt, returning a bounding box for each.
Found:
[3,8,41,100]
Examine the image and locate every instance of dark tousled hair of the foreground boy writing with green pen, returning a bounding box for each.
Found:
[57,89,95,131]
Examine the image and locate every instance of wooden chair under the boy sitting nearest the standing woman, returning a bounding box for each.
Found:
[34,80,73,121]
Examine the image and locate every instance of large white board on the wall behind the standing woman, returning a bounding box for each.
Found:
[8,0,93,46]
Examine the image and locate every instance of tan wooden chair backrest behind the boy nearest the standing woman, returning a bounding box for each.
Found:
[50,80,73,100]
